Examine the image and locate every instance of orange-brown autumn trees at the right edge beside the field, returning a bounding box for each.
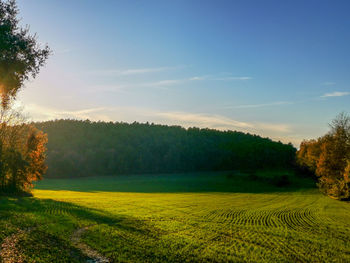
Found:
[297,113,350,199]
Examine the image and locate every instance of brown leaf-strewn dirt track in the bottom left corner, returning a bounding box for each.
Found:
[0,228,31,263]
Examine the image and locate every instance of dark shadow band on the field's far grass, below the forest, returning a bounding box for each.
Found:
[35,173,315,193]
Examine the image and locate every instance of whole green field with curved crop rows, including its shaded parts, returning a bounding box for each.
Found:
[0,173,350,262]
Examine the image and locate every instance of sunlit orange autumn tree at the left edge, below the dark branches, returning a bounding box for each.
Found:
[0,104,47,192]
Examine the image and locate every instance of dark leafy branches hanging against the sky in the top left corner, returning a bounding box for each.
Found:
[0,0,50,107]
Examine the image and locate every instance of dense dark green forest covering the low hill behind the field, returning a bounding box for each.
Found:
[34,120,296,177]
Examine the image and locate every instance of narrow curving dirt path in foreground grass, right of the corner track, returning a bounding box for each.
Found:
[72,226,110,263]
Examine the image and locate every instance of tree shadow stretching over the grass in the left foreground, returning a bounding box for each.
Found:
[0,197,161,262]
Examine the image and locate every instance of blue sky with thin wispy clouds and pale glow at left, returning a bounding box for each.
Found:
[17,0,350,146]
